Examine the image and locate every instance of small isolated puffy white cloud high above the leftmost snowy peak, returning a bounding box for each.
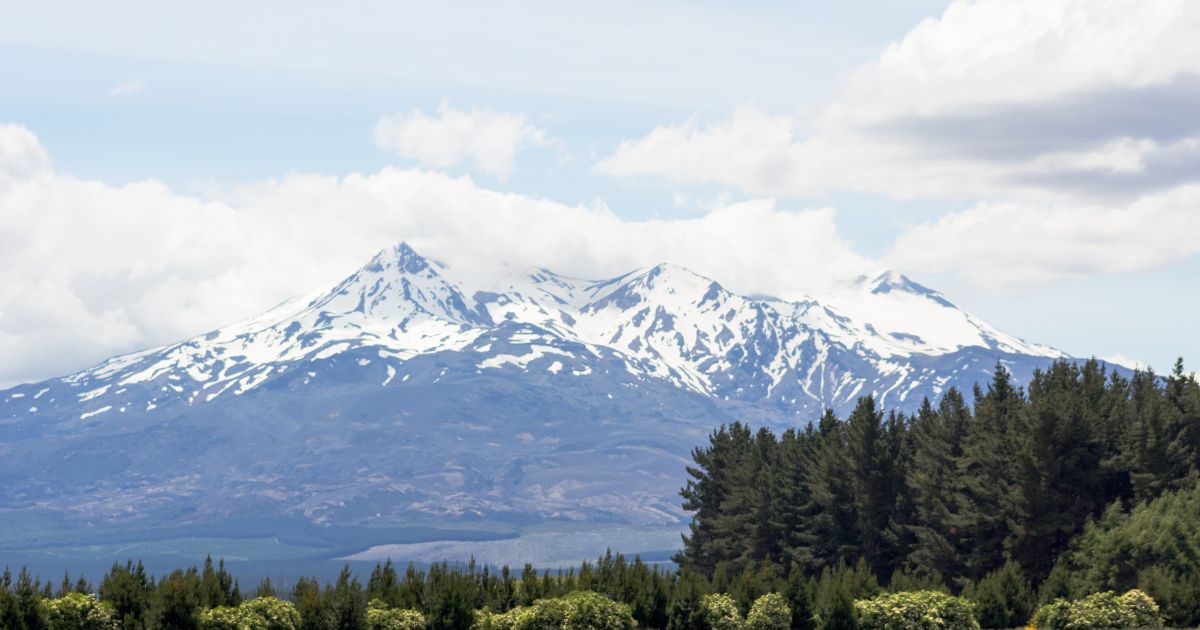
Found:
[374,101,547,180]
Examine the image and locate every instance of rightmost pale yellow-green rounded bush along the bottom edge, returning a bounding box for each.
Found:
[1033,589,1163,630]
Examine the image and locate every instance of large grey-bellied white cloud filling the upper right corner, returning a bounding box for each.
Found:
[596,0,1200,202]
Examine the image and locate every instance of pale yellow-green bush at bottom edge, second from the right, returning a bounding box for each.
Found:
[854,590,979,630]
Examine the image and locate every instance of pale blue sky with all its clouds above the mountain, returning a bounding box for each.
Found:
[0,0,1200,384]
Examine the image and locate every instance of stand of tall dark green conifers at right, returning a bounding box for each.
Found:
[676,360,1200,622]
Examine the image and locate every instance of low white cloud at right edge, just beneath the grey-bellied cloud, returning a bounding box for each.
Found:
[888,185,1200,287]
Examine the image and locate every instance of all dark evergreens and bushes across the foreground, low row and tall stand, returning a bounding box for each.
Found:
[7,361,1200,630]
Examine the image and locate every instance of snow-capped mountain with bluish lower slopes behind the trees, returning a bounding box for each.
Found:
[0,244,1063,549]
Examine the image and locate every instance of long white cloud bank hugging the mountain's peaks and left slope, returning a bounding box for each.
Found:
[0,126,875,383]
